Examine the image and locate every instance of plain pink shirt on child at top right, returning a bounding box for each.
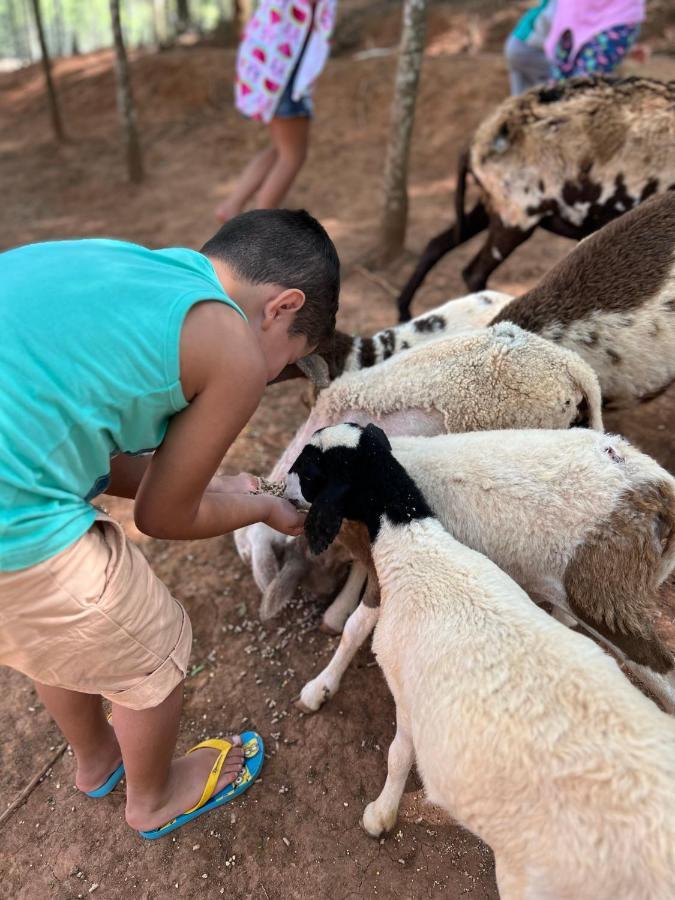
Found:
[544,0,645,59]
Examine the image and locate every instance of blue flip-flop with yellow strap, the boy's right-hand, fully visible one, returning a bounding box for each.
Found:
[138,731,265,841]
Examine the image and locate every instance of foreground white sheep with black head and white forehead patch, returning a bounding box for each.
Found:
[292,425,675,900]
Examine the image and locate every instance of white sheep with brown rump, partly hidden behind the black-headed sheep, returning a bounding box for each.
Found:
[292,429,675,713]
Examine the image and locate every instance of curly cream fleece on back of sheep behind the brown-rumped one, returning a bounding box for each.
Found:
[314,322,602,432]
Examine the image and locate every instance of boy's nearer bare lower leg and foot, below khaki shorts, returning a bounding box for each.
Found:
[113,685,244,831]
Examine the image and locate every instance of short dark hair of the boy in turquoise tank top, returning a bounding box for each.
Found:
[201,209,340,347]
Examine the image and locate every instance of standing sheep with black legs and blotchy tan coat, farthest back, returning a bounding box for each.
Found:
[397,77,675,321]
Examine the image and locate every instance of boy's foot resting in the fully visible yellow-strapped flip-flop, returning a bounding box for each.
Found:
[126,735,244,831]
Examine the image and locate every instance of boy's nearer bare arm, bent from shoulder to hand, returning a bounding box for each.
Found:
[134,304,304,540]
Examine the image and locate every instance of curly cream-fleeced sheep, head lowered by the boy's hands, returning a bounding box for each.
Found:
[235,323,602,604]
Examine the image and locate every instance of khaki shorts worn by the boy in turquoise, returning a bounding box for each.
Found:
[0,514,192,709]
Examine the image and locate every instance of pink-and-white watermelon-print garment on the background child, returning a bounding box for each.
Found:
[235,0,337,122]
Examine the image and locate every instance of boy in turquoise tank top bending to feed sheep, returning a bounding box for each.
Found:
[0,210,340,838]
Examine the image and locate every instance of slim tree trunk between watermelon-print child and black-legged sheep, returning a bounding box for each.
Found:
[377,0,428,265]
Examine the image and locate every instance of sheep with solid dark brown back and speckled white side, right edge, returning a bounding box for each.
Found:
[492,195,675,406]
